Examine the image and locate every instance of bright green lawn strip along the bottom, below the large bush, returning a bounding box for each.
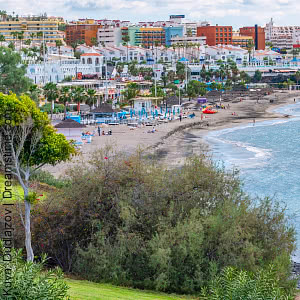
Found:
[66,278,196,300]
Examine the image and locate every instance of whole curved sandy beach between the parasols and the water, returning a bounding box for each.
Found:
[44,91,300,177]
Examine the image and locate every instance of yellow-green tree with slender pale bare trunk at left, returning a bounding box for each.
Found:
[0,94,76,262]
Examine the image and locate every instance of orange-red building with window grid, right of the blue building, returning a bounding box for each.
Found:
[197,25,232,46]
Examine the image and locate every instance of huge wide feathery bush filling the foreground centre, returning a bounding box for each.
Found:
[12,147,294,293]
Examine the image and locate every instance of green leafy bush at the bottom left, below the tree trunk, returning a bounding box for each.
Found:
[0,241,68,300]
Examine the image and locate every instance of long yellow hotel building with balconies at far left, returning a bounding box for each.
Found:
[0,20,62,42]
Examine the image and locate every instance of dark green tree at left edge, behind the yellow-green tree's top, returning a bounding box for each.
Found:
[0,47,31,95]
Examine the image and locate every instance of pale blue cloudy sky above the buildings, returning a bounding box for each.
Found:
[0,0,300,29]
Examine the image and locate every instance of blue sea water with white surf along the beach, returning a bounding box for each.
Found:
[204,102,300,262]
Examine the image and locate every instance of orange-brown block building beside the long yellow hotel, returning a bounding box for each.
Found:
[66,23,99,46]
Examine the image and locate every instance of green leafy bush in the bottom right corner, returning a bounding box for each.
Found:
[200,266,295,300]
